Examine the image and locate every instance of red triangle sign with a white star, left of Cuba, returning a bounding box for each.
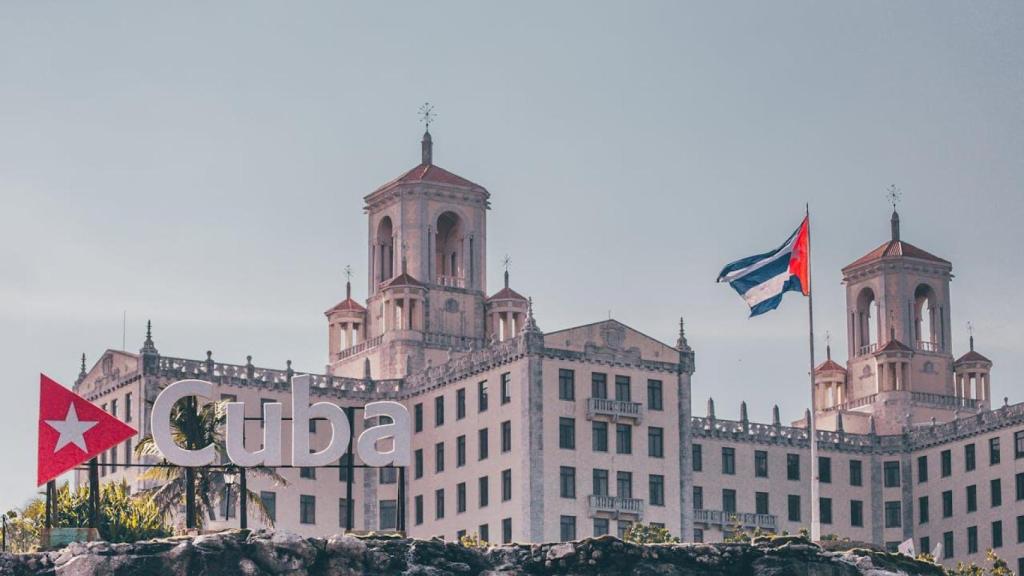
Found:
[36,374,138,486]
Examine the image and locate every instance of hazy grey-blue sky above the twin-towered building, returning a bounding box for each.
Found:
[0,1,1024,509]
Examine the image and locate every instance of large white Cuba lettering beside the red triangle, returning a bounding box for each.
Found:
[151,375,412,467]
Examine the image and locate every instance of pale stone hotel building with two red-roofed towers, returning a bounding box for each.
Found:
[68,132,1024,562]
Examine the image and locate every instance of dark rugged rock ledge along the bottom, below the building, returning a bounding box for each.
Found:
[0,531,944,576]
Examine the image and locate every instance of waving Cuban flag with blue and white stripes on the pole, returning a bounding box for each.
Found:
[718,217,811,317]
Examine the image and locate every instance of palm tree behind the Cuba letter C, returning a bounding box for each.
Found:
[135,398,288,528]
